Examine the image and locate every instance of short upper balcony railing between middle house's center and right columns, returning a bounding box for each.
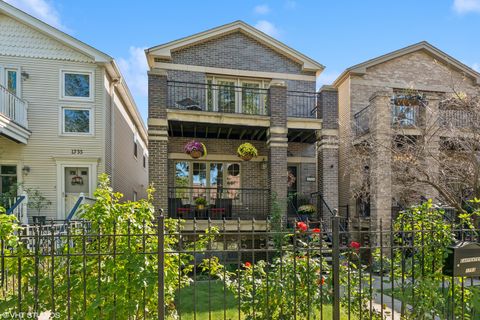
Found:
[287,91,318,118]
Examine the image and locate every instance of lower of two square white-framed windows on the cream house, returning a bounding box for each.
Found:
[62,107,93,135]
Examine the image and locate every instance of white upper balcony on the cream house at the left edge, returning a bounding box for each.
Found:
[0,85,31,144]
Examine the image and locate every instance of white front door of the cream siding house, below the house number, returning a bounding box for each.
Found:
[64,167,90,218]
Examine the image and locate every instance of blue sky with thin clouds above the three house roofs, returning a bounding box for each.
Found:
[6,0,480,121]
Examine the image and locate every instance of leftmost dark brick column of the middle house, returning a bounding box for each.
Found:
[148,70,168,213]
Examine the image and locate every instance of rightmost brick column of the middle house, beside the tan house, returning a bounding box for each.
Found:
[317,86,340,219]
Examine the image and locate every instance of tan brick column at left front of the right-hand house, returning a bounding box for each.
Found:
[370,91,392,228]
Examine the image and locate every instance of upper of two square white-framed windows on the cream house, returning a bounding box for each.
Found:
[61,71,93,100]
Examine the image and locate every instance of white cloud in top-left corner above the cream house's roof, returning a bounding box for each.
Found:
[5,0,68,31]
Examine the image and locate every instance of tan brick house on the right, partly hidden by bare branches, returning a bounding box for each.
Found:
[333,42,480,228]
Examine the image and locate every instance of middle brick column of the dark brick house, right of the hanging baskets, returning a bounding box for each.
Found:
[267,80,288,218]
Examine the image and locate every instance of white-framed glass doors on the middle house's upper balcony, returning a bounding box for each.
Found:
[206,76,267,115]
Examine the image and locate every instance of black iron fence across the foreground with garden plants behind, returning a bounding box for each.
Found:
[0,217,480,320]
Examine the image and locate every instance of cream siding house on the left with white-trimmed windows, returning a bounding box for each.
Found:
[0,2,148,219]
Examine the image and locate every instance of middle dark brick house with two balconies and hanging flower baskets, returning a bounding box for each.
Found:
[146,21,338,226]
